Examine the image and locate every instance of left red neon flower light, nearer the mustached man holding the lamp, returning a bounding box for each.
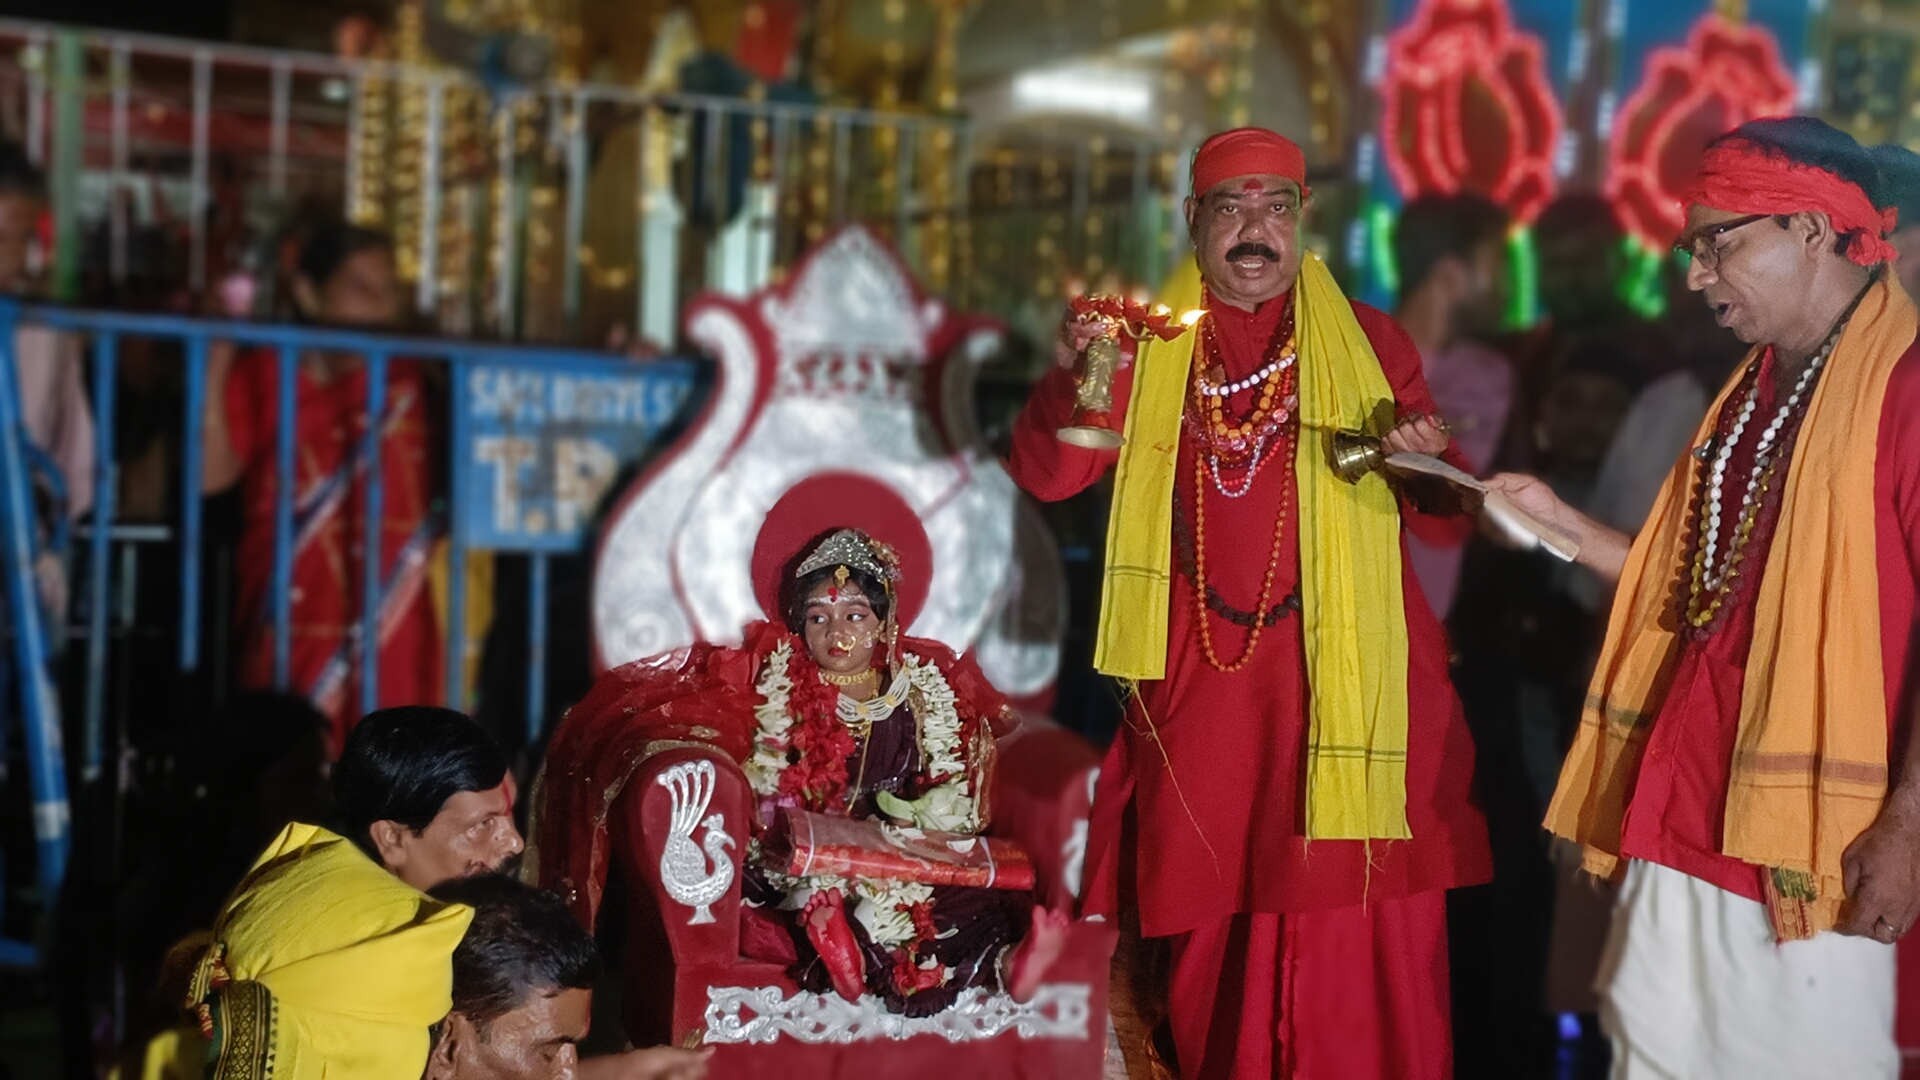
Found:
[1380,0,1561,221]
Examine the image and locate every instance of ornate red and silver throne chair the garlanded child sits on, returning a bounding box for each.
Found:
[536,227,1114,1078]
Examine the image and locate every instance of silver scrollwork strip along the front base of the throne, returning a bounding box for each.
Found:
[707,984,1092,1045]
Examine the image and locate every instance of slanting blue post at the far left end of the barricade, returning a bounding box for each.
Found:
[0,298,71,905]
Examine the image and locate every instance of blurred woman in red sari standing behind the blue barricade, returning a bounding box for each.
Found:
[204,221,445,755]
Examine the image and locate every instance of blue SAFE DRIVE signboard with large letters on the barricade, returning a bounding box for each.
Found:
[453,359,699,552]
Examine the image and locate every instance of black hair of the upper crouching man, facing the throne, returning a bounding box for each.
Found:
[334,705,507,861]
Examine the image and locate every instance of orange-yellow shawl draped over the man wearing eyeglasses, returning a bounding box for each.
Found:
[1546,277,1920,940]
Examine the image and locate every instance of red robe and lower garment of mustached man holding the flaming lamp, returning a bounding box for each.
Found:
[1008,290,1492,1078]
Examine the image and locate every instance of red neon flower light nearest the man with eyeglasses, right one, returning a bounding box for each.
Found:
[1607,13,1793,248]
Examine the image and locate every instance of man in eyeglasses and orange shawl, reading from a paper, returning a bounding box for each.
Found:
[1494,117,1920,1080]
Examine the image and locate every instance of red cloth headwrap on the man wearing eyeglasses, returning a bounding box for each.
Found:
[1682,138,1899,267]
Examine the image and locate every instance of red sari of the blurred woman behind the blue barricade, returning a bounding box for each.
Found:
[227,350,445,753]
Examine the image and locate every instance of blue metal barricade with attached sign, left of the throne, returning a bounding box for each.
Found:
[0,298,701,933]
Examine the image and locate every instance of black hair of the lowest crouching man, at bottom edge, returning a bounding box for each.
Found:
[428,874,601,1038]
